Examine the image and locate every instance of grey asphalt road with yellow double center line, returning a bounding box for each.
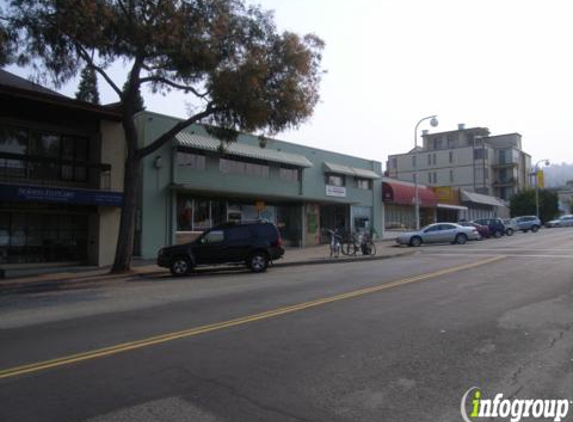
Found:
[0,229,573,422]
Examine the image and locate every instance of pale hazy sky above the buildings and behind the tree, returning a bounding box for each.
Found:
[5,0,573,168]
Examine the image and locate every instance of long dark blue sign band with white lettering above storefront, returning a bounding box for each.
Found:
[0,185,123,207]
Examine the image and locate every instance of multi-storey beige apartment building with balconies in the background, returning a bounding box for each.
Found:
[387,124,531,200]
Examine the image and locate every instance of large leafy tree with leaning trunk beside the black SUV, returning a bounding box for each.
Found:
[7,0,323,272]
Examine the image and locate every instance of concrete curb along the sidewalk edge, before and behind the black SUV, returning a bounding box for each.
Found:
[0,251,416,296]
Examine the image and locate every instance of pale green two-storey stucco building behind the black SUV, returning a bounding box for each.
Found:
[135,112,382,258]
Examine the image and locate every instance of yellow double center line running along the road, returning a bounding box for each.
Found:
[0,256,505,379]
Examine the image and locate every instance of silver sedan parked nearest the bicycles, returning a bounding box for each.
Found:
[396,223,479,246]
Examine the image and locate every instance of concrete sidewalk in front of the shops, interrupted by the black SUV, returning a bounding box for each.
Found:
[0,239,406,295]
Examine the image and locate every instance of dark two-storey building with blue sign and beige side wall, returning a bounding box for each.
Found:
[0,70,126,268]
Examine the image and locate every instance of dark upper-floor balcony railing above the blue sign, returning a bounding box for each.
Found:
[0,152,111,190]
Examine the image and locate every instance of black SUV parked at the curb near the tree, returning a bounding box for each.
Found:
[157,222,285,276]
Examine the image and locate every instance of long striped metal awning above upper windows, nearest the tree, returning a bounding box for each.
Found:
[175,132,312,168]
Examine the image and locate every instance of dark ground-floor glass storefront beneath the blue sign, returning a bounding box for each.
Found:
[0,211,88,264]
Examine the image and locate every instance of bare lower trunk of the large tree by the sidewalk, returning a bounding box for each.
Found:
[111,154,141,273]
